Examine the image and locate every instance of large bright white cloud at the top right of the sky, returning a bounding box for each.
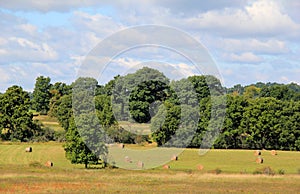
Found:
[170,0,300,37]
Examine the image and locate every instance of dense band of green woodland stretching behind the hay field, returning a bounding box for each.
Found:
[0,67,300,166]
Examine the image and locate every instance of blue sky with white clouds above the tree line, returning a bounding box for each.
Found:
[0,0,300,92]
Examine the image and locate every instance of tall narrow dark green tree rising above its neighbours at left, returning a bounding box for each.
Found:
[32,76,51,114]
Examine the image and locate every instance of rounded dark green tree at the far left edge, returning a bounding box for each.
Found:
[0,86,40,141]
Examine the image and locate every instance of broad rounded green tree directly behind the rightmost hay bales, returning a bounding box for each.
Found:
[240,97,283,149]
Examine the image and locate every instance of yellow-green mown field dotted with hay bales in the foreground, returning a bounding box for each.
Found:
[0,142,300,193]
